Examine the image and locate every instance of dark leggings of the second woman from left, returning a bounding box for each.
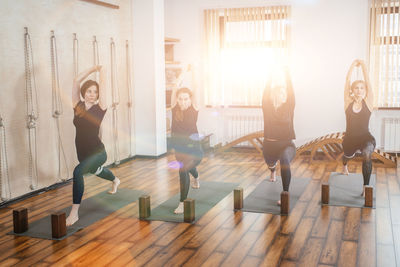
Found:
[175,153,202,202]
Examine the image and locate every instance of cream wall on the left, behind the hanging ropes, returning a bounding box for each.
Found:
[0,0,134,201]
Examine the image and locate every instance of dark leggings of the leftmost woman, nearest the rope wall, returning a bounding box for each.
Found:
[72,150,115,204]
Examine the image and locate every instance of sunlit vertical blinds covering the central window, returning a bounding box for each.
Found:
[204,6,290,106]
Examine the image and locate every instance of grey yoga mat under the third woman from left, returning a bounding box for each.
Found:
[242,177,311,214]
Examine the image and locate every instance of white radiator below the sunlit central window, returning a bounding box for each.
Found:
[224,114,264,147]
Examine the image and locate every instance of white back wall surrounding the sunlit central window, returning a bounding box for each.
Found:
[165,0,379,147]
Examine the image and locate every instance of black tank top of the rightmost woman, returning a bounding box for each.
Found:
[346,100,371,136]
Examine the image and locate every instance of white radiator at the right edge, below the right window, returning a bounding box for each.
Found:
[381,118,400,152]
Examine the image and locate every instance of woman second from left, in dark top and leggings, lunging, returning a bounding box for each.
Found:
[171,88,203,214]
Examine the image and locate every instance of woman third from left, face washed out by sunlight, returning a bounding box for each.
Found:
[262,70,296,204]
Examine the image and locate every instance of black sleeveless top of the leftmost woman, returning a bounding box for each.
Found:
[74,101,107,162]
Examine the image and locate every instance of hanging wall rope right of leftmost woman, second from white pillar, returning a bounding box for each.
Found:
[110,38,120,165]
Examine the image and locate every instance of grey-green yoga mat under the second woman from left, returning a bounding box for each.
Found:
[145,180,238,222]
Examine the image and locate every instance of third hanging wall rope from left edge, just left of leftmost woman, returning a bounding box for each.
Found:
[50,31,69,181]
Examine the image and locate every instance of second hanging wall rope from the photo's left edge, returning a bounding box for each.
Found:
[24,27,39,190]
